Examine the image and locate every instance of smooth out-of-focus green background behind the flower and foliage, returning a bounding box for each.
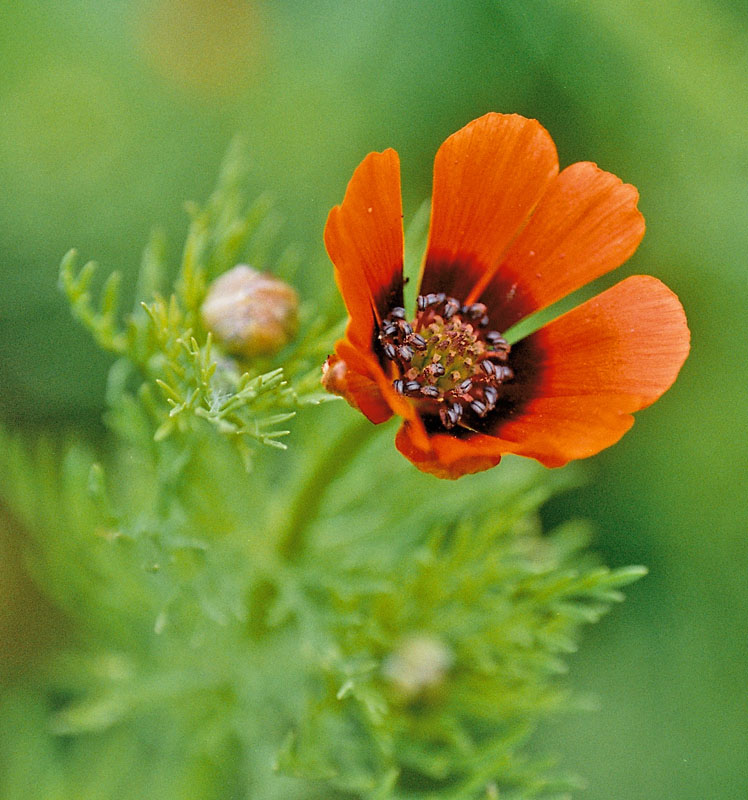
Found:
[0,0,748,800]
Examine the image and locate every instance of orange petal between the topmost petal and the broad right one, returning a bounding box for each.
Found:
[468,161,645,331]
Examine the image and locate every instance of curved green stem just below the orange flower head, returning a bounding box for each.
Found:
[278,418,377,561]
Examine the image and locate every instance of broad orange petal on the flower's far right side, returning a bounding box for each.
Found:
[491,275,690,467]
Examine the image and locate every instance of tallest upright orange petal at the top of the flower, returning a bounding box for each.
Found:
[420,113,558,308]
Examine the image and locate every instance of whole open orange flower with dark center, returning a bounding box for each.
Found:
[323,113,689,478]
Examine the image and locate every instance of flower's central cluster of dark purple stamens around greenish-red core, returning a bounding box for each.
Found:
[379,292,514,430]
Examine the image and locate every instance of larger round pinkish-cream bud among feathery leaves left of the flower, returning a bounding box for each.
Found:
[201,264,299,358]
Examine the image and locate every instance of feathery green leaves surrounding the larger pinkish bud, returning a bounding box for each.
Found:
[60,142,338,467]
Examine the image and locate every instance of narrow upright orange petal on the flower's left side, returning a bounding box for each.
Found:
[325,149,403,351]
